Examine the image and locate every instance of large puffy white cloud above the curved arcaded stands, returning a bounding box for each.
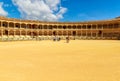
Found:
[12,0,67,21]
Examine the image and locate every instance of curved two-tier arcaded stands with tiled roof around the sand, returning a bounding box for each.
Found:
[0,17,120,41]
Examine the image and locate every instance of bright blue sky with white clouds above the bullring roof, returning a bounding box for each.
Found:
[0,0,120,22]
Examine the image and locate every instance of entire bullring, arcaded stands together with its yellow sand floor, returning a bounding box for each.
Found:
[0,17,120,81]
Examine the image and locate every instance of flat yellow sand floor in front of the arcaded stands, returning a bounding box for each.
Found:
[0,40,120,81]
